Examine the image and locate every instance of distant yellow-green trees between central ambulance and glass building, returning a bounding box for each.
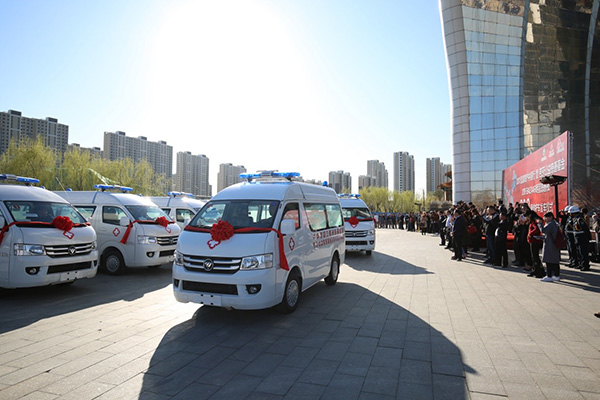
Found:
[360,187,451,213]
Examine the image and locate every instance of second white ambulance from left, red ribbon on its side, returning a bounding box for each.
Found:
[56,185,181,274]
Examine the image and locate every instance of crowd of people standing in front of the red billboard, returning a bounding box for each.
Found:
[375,200,600,282]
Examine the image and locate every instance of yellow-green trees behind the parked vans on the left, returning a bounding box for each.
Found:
[0,139,171,196]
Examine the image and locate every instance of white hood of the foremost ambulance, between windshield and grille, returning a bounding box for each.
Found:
[177,230,276,257]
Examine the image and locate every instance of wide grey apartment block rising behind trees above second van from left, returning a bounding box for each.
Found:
[103,131,173,178]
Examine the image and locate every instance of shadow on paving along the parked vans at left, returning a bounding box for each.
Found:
[0,265,171,333]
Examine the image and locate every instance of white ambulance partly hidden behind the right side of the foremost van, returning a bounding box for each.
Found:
[339,194,375,255]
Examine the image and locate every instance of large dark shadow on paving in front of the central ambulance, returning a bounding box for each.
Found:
[139,283,474,400]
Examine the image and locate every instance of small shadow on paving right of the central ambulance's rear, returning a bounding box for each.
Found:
[344,251,433,275]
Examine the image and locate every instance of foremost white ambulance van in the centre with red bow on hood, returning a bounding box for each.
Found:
[173,171,345,312]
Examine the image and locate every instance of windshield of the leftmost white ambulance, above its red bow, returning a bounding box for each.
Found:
[4,200,86,224]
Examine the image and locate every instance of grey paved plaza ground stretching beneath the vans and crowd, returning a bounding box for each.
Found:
[0,230,600,400]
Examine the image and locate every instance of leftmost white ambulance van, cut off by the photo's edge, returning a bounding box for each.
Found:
[0,174,98,288]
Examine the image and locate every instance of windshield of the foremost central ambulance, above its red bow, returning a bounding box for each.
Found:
[190,200,279,229]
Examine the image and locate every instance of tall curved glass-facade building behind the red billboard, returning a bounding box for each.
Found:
[440,0,600,205]
